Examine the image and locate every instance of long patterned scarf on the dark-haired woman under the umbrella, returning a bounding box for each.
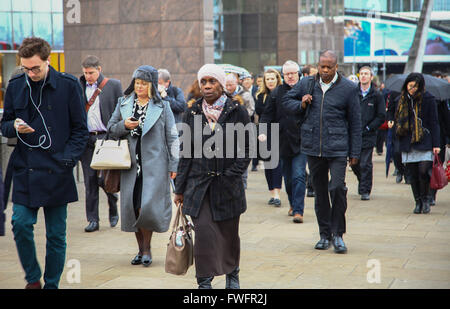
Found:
[395,93,423,143]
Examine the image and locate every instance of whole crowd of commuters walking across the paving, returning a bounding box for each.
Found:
[0,38,450,289]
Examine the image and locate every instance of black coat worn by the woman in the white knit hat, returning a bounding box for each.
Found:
[175,98,255,221]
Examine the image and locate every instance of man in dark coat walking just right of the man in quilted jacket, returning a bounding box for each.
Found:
[352,66,386,201]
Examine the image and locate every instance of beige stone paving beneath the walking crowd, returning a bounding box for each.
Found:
[0,155,450,289]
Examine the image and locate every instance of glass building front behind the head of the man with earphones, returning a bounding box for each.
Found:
[0,0,64,108]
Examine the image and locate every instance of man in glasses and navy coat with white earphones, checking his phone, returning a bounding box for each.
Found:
[1,37,88,288]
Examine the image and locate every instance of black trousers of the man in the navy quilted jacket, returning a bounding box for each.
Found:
[308,156,347,239]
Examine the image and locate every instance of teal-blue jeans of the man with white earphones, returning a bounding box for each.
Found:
[12,204,67,289]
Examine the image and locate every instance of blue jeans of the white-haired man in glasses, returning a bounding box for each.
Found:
[281,153,307,216]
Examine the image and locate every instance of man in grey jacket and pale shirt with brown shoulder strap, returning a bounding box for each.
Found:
[80,55,123,232]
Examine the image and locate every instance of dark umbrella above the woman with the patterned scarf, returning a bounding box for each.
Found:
[385,74,450,101]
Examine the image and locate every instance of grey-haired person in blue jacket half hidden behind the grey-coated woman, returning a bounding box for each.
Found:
[158,69,187,123]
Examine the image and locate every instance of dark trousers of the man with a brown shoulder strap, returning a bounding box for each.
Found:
[81,134,118,222]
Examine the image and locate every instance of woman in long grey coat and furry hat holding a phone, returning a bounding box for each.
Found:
[108,65,179,266]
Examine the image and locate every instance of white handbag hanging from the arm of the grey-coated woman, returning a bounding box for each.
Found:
[91,139,131,170]
